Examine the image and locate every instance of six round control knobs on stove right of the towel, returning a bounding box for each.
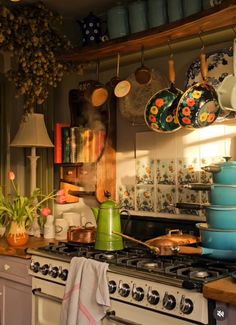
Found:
[108,280,193,315]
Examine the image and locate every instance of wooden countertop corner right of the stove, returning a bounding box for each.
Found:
[203,277,236,305]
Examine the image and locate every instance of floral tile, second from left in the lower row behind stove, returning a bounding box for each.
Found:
[136,186,155,212]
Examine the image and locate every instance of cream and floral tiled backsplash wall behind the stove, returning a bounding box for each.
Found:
[118,124,236,216]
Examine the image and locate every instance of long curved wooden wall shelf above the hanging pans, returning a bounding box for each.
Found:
[61,0,236,63]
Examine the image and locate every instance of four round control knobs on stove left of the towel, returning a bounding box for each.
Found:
[30,262,68,281]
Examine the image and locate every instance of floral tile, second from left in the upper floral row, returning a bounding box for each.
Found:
[156,159,176,185]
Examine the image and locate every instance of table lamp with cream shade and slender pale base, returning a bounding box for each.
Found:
[10,113,54,194]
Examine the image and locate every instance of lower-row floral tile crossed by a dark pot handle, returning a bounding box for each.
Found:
[178,186,201,216]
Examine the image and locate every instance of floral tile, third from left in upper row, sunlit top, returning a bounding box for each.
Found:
[177,158,199,185]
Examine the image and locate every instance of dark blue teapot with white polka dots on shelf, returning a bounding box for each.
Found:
[77,12,105,46]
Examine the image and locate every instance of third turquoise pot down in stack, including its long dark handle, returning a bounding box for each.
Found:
[174,203,236,230]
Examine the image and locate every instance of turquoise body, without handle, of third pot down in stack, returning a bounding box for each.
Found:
[205,205,236,230]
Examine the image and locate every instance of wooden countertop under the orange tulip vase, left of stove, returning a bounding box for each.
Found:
[0,236,57,258]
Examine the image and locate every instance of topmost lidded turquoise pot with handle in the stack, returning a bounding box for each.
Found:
[202,157,236,185]
